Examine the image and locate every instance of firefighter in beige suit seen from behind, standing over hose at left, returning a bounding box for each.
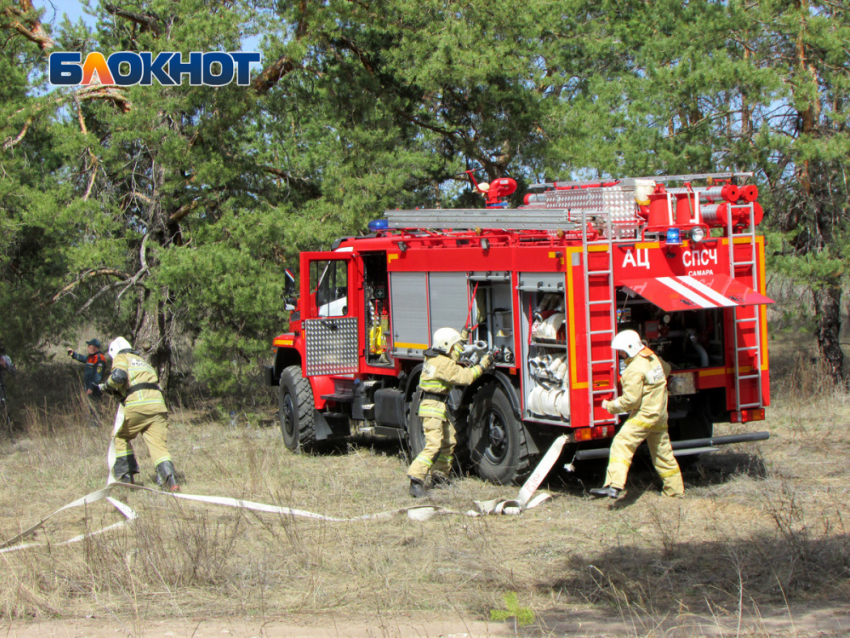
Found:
[100,337,180,492]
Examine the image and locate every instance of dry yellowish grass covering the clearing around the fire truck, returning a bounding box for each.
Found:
[0,352,850,636]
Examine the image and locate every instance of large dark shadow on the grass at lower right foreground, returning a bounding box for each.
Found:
[538,530,850,615]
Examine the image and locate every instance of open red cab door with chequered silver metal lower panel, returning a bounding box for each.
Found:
[301,253,359,376]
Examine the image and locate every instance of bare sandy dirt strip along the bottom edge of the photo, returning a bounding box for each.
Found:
[0,606,850,638]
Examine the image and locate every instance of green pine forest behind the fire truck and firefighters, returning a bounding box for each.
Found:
[0,0,850,394]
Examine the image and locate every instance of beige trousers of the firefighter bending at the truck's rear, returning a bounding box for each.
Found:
[605,420,685,496]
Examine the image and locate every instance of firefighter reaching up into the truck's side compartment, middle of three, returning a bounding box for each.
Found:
[407,328,493,498]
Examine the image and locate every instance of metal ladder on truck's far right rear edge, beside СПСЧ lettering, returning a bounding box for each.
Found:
[726,204,764,413]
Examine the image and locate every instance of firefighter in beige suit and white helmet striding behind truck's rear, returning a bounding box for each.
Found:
[590,330,685,498]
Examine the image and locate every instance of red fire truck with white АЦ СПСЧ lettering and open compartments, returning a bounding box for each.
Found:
[266,173,772,483]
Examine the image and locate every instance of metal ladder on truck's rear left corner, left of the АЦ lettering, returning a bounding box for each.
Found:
[567,211,617,427]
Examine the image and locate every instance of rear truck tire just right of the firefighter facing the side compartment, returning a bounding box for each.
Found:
[467,382,531,485]
